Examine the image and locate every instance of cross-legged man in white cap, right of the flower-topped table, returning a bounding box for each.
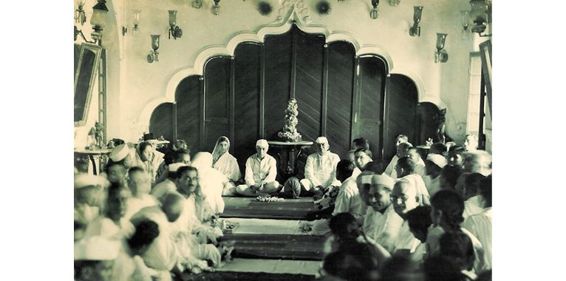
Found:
[301,137,340,195]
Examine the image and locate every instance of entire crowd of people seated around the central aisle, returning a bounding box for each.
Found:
[74,132,492,281]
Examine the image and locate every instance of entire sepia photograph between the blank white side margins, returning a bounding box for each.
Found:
[72,0,502,281]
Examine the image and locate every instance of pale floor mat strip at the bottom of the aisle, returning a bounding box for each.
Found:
[216,258,321,275]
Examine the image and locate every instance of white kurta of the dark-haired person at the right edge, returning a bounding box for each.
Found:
[462,207,493,268]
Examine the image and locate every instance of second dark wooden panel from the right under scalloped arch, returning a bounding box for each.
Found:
[383,74,419,162]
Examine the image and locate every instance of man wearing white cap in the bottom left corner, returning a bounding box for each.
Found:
[75,236,120,281]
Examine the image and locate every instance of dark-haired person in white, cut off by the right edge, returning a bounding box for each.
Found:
[462,176,493,269]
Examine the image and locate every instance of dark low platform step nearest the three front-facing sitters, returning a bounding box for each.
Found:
[221,197,316,220]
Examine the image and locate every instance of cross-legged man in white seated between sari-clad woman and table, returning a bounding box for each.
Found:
[236,139,281,196]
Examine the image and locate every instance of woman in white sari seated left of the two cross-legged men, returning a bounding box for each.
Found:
[212,136,242,183]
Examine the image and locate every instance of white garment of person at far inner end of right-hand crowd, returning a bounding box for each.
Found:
[332,177,363,217]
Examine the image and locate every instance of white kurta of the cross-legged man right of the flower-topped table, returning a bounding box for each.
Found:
[304,151,340,190]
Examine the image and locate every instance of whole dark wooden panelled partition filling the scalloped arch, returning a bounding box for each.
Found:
[151,23,428,168]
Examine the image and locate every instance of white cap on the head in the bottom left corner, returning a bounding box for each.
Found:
[75,236,120,261]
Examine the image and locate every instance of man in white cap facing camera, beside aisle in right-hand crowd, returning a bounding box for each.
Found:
[362,175,403,252]
